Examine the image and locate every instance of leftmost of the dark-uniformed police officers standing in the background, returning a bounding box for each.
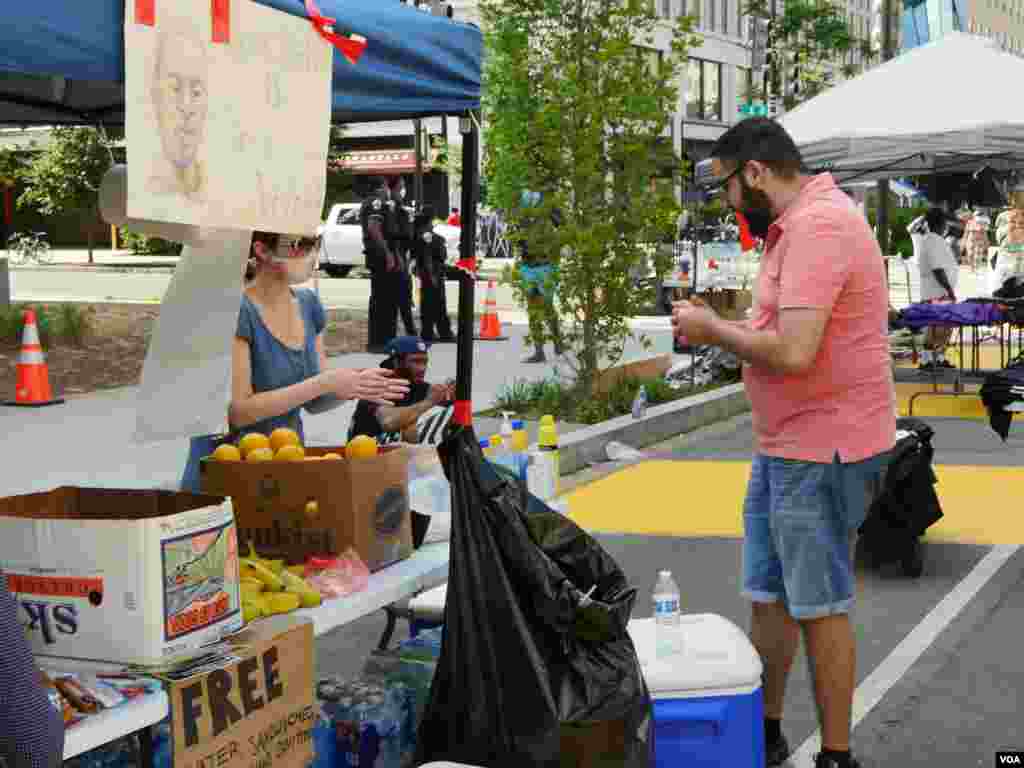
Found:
[359,178,398,352]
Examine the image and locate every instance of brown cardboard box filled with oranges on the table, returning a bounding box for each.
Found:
[200,429,413,571]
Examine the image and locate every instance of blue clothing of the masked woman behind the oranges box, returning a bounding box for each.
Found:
[181,289,327,493]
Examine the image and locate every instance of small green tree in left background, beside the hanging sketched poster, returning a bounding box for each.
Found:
[17,128,111,264]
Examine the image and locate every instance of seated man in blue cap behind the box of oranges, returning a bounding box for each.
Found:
[348,336,455,445]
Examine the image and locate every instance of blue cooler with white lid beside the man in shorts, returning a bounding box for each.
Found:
[629,613,765,768]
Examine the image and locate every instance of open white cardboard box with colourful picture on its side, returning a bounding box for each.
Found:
[0,486,243,664]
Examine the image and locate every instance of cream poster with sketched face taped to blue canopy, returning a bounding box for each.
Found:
[125,0,334,233]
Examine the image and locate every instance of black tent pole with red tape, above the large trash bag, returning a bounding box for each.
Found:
[453,113,480,426]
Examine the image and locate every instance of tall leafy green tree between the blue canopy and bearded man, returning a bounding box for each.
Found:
[480,0,696,396]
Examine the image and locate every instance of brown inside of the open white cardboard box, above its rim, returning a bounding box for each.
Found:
[0,486,224,520]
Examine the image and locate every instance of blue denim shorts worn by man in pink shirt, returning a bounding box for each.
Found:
[742,453,889,620]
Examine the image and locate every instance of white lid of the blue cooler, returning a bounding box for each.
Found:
[629,613,762,697]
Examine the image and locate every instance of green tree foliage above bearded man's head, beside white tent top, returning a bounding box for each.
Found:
[744,0,856,110]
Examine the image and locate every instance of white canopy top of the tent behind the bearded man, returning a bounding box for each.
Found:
[779,33,1024,182]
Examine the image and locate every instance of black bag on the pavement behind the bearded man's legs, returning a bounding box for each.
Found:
[859,418,942,561]
